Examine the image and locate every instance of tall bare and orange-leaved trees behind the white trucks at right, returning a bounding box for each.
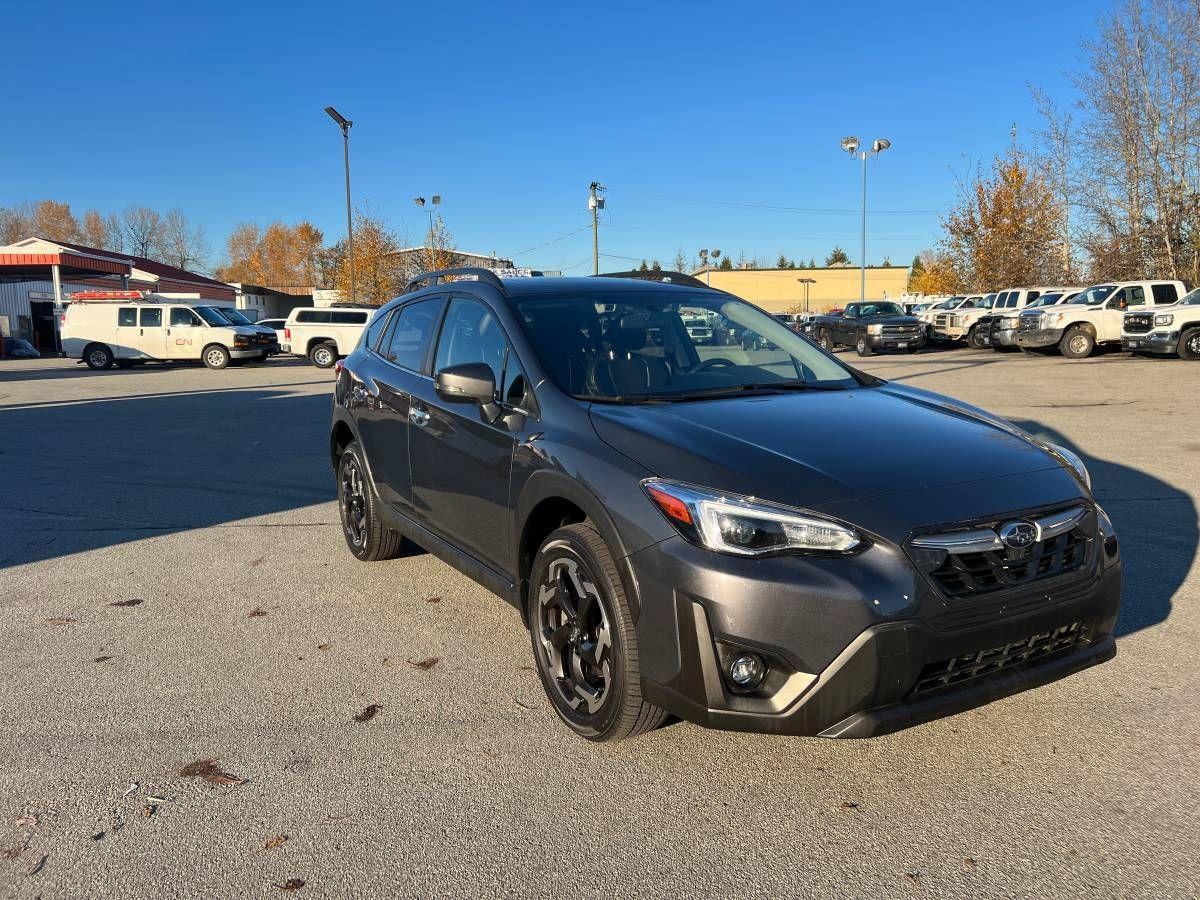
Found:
[910,0,1200,294]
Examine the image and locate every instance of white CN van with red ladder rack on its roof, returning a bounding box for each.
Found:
[61,290,272,368]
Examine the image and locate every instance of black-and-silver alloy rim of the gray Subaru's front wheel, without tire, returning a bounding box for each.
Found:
[538,558,613,715]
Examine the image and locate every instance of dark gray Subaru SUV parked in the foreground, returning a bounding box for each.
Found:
[329,269,1121,740]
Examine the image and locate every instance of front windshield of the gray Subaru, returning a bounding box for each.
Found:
[515,290,862,403]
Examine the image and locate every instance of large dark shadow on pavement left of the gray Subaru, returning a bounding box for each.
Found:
[0,389,337,568]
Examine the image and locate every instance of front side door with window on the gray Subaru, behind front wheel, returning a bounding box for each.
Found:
[409,295,526,574]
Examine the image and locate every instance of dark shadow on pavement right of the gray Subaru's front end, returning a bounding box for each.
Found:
[1013,419,1200,637]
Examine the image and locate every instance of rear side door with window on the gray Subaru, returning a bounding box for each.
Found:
[355,296,445,515]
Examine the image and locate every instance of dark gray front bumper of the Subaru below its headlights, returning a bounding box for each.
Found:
[629,528,1121,738]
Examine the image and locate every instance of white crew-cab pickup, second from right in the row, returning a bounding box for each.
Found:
[1016,281,1187,359]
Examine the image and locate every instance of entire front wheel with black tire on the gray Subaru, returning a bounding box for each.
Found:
[527,523,666,742]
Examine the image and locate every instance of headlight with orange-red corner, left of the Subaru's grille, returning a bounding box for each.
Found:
[642,479,863,557]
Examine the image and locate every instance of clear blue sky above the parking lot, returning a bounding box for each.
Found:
[0,0,1099,274]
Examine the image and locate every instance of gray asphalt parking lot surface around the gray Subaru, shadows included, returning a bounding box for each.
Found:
[0,350,1200,898]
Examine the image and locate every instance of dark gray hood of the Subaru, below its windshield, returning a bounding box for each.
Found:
[592,384,1078,515]
